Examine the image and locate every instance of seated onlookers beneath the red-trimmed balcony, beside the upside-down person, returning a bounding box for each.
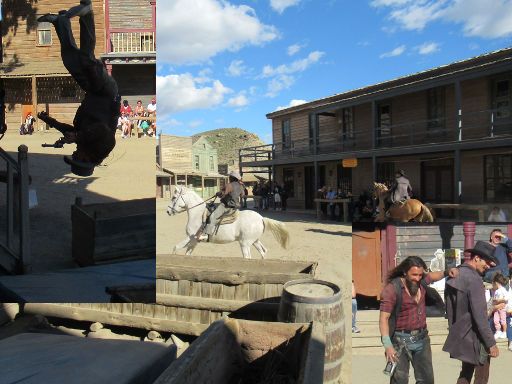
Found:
[117,98,156,139]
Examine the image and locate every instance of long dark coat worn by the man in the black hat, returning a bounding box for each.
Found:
[443,264,496,365]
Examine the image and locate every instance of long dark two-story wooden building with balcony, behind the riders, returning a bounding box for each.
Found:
[241,48,512,212]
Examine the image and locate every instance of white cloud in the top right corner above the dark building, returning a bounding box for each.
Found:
[371,0,512,38]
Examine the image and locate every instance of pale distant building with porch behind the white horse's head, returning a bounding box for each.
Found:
[158,134,226,198]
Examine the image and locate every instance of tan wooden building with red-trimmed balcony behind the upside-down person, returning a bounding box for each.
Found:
[0,0,156,130]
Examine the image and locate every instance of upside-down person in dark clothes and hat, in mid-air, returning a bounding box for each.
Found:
[38,0,121,176]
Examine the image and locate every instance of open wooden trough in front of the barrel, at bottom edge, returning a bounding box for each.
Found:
[154,319,325,384]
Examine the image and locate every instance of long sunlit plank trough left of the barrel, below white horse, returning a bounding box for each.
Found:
[24,255,317,336]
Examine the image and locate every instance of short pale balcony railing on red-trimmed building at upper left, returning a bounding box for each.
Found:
[109,31,156,53]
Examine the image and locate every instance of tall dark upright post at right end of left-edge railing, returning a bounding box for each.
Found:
[18,144,32,273]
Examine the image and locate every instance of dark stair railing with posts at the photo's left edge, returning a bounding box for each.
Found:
[0,145,30,273]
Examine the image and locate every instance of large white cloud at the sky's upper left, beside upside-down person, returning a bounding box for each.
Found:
[157,0,279,64]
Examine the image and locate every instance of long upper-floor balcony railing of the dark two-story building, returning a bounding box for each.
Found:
[240,109,512,162]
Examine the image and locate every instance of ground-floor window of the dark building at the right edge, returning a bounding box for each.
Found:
[484,155,512,203]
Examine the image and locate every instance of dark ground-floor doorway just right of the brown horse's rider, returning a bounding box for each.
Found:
[422,159,454,203]
